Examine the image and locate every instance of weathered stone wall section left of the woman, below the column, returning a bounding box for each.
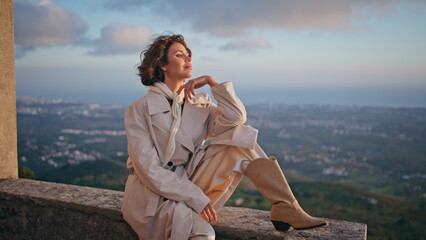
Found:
[0,179,137,240]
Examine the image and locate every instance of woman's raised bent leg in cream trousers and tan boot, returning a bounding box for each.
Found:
[191,144,327,231]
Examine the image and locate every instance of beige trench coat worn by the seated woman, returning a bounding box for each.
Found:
[122,82,257,239]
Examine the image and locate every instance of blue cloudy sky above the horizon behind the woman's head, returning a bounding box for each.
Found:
[14,0,426,107]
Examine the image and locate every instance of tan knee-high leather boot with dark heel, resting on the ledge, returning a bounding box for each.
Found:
[245,157,327,231]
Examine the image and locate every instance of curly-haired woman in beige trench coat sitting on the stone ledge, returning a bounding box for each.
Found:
[122,35,327,239]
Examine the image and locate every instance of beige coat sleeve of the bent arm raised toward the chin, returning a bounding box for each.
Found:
[207,82,247,138]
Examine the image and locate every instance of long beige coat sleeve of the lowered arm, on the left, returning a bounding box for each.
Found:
[124,101,210,213]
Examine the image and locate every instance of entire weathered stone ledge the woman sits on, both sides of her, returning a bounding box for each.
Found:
[0,179,367,239]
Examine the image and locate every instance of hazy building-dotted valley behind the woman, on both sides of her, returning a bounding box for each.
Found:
[17,97,426,199]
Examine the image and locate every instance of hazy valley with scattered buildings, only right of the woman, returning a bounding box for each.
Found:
[247,104,426,192]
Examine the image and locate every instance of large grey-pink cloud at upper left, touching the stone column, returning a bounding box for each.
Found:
[14,0,87,57]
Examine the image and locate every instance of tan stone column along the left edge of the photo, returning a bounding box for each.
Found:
[0,0,18,179]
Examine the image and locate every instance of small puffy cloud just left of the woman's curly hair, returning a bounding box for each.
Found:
[86,23,153,55]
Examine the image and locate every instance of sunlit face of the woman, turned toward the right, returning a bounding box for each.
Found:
[162,42,192,81]
